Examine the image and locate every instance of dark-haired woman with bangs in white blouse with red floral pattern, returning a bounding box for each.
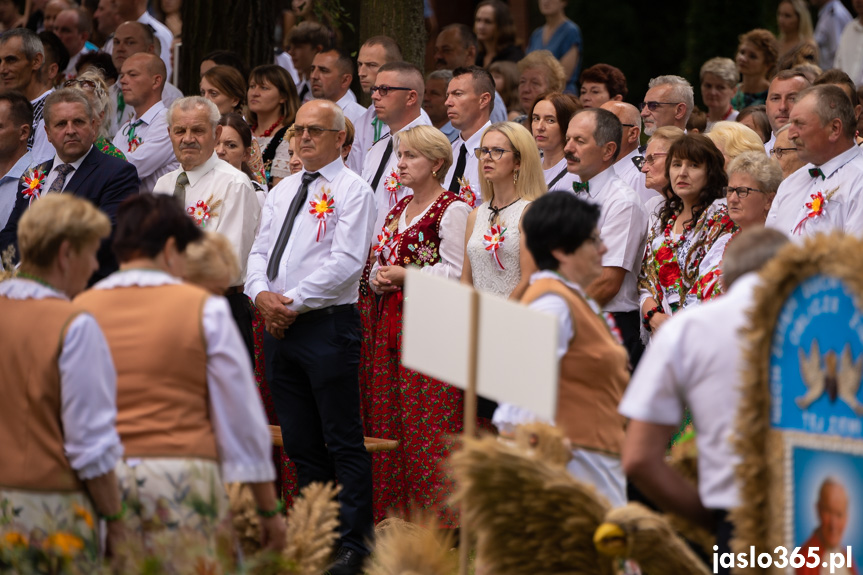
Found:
[638,134,736,333]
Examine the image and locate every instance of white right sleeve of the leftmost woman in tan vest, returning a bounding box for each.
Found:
[59,313,123,480]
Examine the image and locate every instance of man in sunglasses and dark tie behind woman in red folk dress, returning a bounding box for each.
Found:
[363,62,431,232]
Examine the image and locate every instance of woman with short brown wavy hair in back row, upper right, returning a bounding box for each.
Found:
[731,28,779,110]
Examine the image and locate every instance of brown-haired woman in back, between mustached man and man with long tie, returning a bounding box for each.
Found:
[247,64,300,188]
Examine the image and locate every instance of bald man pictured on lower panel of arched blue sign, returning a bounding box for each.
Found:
[797,477,859,575]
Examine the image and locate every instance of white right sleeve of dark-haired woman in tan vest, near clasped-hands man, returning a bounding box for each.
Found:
[203,297,276,483]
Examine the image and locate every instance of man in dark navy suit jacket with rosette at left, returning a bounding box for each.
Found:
[0,88,138,284]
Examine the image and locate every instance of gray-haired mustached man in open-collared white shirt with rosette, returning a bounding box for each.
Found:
[153,96,261,288]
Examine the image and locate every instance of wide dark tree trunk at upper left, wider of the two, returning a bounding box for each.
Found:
[178,0,276,94]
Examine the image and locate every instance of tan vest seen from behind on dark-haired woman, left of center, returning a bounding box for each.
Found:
[75,284,218,460]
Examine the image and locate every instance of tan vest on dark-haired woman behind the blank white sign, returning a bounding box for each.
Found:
[521,278,629,456]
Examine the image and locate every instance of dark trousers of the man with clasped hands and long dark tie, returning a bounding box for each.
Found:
[264,306,374,554]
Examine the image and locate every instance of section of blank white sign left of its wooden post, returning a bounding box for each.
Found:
[402,268,473,389]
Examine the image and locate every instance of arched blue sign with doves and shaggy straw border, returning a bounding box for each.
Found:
[731,234,863,573]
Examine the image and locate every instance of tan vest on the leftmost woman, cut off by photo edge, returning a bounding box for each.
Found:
[0,297,83,492]
